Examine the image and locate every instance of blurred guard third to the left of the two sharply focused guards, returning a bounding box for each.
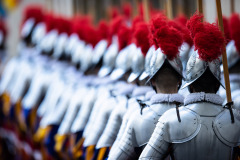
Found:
[83,14,135,159]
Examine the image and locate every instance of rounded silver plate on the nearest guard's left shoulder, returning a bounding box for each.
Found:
[158,107,201,143]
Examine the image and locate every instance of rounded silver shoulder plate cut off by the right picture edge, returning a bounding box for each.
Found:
[213,109,240,147]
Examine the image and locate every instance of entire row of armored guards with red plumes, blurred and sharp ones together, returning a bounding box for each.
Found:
[1,3,239,159]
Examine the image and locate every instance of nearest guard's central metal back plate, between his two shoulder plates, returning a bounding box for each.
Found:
[173,117,231,160]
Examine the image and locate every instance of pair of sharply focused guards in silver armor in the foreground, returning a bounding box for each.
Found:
[109,14,240,160]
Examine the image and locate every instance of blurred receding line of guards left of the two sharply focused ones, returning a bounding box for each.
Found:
[1,3,156,159]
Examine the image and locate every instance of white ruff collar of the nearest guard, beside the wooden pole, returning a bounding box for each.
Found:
[184,92,223,106]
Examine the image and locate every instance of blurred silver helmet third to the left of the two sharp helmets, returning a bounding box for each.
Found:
[110,44,136,80]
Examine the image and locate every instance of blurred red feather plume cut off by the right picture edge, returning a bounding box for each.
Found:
[229,13,240,53]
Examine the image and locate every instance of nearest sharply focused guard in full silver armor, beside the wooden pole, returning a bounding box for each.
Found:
[140,14,240,160]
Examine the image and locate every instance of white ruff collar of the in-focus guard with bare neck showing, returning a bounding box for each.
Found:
[151,93,184,104]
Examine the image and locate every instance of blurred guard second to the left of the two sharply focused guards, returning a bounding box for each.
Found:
[96,22,152,159]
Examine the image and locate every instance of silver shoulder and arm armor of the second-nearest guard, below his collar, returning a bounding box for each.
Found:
[110,103,176,159]
